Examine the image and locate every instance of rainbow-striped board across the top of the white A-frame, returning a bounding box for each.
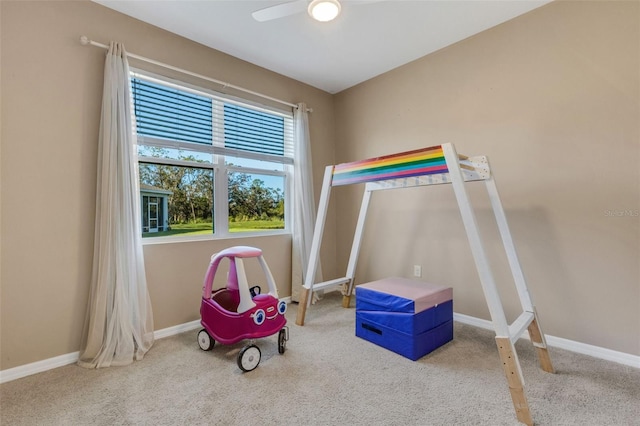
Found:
[331,145,449,186]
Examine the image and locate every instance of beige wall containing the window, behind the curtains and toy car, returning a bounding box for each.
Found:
[0,1,335,370]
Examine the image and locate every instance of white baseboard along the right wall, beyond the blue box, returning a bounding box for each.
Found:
[453,313,640,368]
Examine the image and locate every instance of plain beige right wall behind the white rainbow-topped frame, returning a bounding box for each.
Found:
[335,2,640,355]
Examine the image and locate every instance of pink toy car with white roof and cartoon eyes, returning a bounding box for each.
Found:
[198,246,289,371]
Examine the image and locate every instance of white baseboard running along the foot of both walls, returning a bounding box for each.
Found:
[0,310,640,383]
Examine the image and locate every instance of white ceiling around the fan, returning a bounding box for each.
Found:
[93,0,551,93]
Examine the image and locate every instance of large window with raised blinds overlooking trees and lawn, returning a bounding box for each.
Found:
[131,72,293,237]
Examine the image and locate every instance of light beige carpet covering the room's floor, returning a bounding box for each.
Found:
[0,293,640,426]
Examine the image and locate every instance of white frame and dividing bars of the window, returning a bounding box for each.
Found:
[129,67,295,245]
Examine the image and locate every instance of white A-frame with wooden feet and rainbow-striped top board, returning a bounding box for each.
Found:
[296,143,554,425]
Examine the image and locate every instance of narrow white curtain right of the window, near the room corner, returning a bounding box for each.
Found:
[291,103,322,301]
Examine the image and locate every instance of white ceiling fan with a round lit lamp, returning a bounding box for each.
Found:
[251,0,383,22]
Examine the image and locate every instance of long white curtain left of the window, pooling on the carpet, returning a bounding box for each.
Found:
[78,42,153,368]
